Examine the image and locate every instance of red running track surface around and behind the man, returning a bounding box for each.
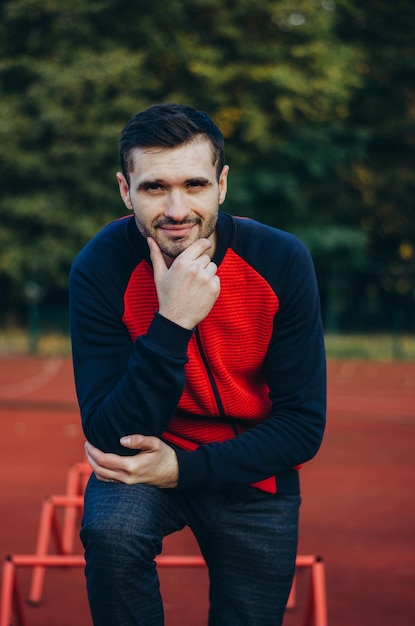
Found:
[0,357,415,626]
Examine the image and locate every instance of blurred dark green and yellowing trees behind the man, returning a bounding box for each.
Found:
[0,0,415,358]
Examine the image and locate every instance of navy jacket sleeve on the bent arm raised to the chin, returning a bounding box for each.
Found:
[69,244,192,455]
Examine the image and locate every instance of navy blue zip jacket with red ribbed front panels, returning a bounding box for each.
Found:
[70,214,326,493]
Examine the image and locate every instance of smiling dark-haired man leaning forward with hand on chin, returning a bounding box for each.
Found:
[70,105,325,626]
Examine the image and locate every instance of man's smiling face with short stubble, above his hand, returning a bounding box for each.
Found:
[117,137,229,262]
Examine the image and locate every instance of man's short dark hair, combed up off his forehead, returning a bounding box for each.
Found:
[119,104,225,183]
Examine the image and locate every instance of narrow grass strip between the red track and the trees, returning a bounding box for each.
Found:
[0,329,415,361]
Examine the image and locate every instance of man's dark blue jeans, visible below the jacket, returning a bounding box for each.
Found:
[81,476,300,626]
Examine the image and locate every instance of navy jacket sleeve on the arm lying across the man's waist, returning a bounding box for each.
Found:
[177,240,326,489]
